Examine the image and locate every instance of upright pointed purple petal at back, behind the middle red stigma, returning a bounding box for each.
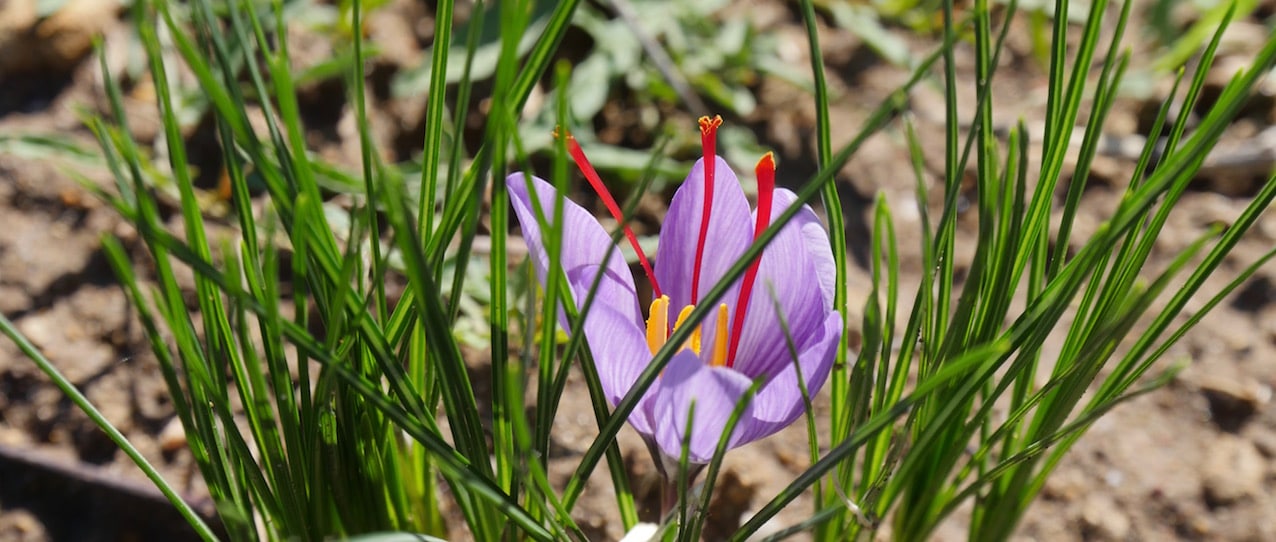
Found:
[656,157,753,316]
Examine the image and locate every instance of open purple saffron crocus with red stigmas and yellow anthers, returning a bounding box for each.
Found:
[505,117,842,466]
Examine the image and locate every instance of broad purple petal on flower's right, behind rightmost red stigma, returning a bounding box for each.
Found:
[734,190,832,377]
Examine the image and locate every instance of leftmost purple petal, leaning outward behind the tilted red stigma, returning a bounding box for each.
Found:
[505,173,651,404]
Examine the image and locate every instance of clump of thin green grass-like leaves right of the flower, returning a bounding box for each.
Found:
[806,1,1276,539]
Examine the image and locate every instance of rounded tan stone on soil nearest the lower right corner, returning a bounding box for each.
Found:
[1202,434,1267,508]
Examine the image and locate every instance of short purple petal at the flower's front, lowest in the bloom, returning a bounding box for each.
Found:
[648,351,753,463]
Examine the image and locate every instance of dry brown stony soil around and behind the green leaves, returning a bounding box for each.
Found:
[0,0,1276,541]
